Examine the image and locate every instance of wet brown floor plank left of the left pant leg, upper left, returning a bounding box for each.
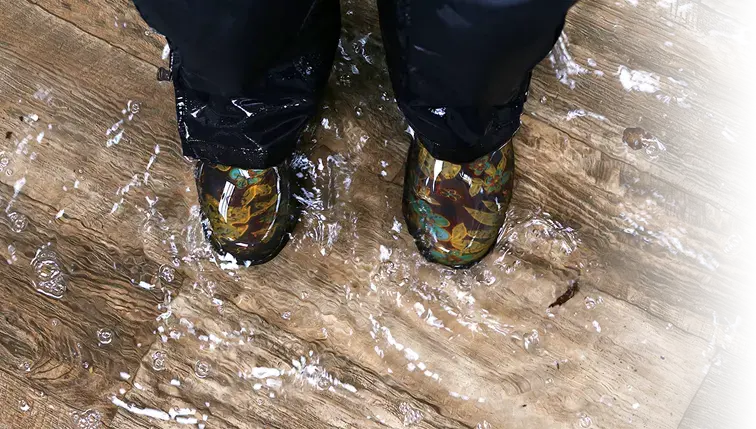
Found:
[0,2,194,258]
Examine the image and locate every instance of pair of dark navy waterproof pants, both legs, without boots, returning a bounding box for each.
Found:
[134,0,577,169]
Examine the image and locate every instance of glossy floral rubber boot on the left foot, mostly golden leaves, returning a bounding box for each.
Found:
[197,161,296,265]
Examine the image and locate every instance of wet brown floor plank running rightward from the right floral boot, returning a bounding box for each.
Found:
[515,113,756,361]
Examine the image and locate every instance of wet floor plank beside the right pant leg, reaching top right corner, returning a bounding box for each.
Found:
[530,0,756,226]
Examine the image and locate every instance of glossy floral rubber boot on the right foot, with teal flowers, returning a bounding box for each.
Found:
[403,140,514,268]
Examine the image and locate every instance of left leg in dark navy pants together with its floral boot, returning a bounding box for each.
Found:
[134,0,340,264]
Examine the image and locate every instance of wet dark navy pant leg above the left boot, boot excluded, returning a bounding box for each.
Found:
[134,0,340,169]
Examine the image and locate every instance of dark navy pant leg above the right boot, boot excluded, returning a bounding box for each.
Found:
[377,0,576,163]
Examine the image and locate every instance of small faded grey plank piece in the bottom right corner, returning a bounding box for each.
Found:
[679,352,756,429]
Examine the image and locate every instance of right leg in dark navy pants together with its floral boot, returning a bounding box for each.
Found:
[379,0,575,268]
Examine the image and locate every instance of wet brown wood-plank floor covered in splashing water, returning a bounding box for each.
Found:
[0,0,756,429]
